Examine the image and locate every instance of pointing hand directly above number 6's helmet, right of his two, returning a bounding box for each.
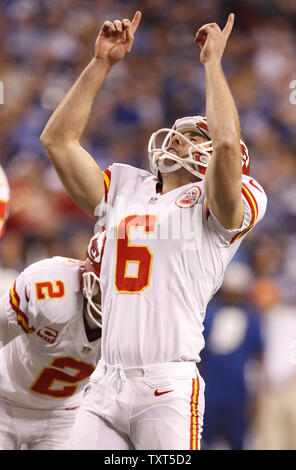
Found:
[194,13,234,64]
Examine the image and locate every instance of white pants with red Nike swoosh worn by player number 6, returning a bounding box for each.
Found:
[69,361,204,450]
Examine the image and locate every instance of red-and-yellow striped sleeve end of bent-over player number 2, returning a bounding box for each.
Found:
[5,272,36,334]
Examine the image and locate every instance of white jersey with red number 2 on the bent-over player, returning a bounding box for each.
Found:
[0,257,100,409]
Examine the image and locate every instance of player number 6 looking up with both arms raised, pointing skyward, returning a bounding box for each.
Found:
[41,11,266,450]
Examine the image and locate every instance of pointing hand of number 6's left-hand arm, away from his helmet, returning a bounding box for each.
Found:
[95,11,142,65]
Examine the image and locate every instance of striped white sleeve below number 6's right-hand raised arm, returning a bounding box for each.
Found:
[205,176,267,246]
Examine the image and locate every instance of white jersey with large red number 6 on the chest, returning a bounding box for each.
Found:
[94,164,266,375]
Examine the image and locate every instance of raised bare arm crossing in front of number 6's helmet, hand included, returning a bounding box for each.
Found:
[195,14,243,229]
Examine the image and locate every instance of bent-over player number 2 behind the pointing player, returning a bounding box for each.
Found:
[0,232,105,450]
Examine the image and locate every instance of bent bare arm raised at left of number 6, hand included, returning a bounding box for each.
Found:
[40,11,141,215]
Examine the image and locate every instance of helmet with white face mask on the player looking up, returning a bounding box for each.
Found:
[148,116,250,179]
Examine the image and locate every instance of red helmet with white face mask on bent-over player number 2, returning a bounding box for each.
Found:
[82,230,106,328]
